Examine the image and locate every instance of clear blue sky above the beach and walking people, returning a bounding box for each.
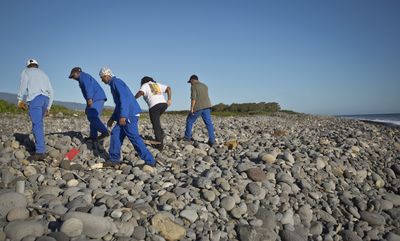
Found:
[0,0,400,114]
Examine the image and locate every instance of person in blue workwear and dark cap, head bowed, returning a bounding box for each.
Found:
[69,67,110,141]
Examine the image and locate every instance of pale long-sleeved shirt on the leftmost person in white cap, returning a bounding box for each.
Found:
[17,68,54,110]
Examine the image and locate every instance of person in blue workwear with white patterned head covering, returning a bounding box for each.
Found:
[99,67,156,167]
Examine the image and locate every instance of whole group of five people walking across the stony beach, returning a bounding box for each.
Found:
[17,59,215,167]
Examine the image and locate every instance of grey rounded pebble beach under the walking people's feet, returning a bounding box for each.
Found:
[0,114,400,241]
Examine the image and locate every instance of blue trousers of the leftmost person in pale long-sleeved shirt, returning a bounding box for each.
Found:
[29,95,49,154]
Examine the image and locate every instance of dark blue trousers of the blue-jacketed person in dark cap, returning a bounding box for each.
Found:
[86,100,108,139]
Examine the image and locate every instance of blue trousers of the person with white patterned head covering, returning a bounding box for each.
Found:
[109,116,156,165]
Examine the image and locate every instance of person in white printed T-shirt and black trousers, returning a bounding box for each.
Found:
[135,76,172,151]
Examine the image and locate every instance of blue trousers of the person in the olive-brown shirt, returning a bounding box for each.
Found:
[185,108,215,143]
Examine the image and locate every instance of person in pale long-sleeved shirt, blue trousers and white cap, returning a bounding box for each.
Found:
[17,59,53,161]
